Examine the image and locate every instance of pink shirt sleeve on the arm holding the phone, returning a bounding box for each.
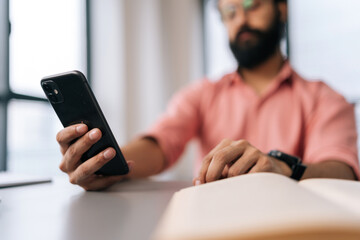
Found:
[143,81,205,168]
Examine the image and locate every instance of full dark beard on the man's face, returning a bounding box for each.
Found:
[230,13,285,69]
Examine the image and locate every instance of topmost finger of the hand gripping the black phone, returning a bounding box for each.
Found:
[56,124,88,155]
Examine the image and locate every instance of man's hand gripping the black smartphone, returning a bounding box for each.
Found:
[56,124,133,190]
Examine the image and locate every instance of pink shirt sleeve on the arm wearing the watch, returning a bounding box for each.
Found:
[303,83,360,179]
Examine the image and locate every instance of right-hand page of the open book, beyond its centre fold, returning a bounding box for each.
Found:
[299,178,360,217]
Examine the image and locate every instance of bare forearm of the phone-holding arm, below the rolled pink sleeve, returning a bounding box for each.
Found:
[121,138,165,178]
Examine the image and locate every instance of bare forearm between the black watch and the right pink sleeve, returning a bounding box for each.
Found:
[301,160,357,180]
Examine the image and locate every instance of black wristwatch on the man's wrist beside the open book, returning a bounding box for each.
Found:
[268,150,306,180]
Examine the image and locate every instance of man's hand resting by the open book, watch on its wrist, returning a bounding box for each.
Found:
[194,139,291,185]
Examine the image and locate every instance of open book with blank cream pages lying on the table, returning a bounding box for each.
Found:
[153,173,360,240]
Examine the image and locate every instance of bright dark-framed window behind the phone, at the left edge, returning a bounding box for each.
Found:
[0,0,87,175]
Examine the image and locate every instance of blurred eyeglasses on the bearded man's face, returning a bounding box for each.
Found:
[219,0,265,21]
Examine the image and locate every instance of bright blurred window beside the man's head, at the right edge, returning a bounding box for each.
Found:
[289,0,360,100]
